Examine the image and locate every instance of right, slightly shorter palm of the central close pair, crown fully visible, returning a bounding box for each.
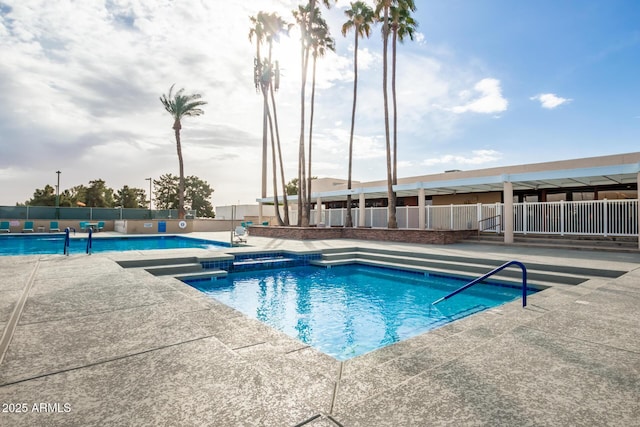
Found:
[305,8,336,222]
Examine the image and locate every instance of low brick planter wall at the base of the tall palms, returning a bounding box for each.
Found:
[249,226,476,245]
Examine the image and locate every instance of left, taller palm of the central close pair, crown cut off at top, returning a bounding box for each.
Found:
[294,0,336,227]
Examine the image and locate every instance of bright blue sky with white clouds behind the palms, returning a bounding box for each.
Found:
[0,0,640,211]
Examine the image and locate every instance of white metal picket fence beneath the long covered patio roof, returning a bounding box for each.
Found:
[290,200,638,236]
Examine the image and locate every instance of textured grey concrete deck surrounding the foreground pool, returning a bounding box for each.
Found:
[0,233,640,427]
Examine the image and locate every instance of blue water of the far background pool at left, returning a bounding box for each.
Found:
[0,234,230,256]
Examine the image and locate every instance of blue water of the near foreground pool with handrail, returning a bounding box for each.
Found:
[187,264,535,360]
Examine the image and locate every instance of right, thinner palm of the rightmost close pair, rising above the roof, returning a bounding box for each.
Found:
[390,0,418,185]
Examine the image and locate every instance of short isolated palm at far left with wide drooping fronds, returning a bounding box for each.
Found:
[160,84,206,219]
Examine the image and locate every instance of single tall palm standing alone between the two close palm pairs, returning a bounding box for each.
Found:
[342,1,374,227]
